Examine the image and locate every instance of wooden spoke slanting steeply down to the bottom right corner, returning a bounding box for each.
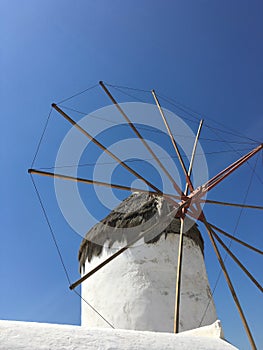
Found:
[203,219,257,350]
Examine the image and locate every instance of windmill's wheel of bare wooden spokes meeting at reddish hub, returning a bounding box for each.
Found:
[29,82,263,349]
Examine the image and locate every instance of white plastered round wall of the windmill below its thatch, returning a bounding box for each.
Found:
[82,234,217,332]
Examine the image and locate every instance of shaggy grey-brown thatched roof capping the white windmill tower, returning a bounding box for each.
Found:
[79,193,204,267]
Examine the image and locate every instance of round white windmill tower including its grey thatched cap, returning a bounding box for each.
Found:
[79,193,217,332]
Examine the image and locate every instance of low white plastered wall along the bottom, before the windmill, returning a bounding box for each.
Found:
[0,321,237,350]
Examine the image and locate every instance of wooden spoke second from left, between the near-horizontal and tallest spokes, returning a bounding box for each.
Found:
[52,103,162,194]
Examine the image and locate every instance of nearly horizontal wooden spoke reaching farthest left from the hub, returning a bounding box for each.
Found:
[28,169,181,204]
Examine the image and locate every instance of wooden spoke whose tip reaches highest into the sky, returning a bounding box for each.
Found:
[99,81,185,194]
